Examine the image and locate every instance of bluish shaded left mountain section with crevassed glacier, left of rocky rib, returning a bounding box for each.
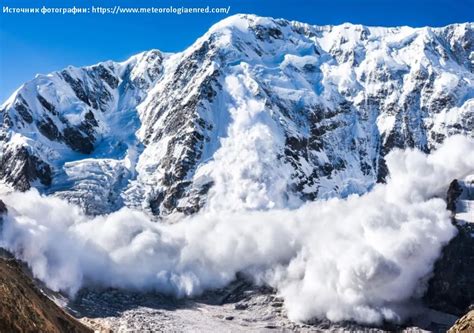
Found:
[0,51,166,213]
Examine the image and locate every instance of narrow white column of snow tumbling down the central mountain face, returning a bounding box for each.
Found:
[196,73,297,211]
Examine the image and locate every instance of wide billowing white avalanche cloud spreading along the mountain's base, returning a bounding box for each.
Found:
[1,136,474,323]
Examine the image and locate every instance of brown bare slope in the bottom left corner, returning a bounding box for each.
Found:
[0,258,92,333]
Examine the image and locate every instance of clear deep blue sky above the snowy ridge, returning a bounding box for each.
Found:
[0,0,474,102]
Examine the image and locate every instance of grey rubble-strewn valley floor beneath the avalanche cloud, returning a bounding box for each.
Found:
[68,280,457,332]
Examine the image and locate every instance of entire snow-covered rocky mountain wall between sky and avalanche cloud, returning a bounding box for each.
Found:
[0,15,474,216]
